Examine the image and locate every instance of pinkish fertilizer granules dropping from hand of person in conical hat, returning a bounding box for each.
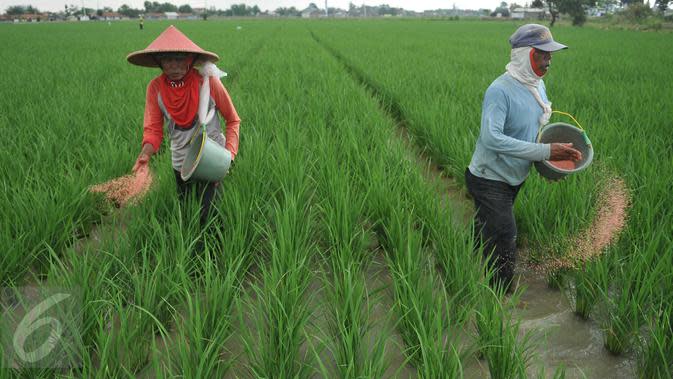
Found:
[89,166,152,207]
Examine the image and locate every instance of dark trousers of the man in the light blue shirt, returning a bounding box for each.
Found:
[465,169,523,289]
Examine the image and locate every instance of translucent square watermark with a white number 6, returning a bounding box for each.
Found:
[0,287,82,368]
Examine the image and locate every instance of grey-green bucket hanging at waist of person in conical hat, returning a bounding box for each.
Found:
[180,128,231,182]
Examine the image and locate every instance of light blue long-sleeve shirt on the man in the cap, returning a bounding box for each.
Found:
[469,73,550,186]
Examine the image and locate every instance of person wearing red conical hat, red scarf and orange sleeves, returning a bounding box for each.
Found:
[126,26,241,224]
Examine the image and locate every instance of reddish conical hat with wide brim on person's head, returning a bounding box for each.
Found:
[126,25,220,67]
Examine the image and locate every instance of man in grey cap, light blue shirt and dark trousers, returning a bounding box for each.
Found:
[465,24,581,291]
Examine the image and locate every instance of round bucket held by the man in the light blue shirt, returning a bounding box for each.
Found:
[535,122,594,180]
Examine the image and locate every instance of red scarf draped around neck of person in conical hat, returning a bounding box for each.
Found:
[159,68,201,126]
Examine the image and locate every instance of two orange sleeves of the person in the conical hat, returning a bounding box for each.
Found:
[142,76,241,159]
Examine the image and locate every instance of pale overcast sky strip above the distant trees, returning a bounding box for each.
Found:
[0,0,504,13]
